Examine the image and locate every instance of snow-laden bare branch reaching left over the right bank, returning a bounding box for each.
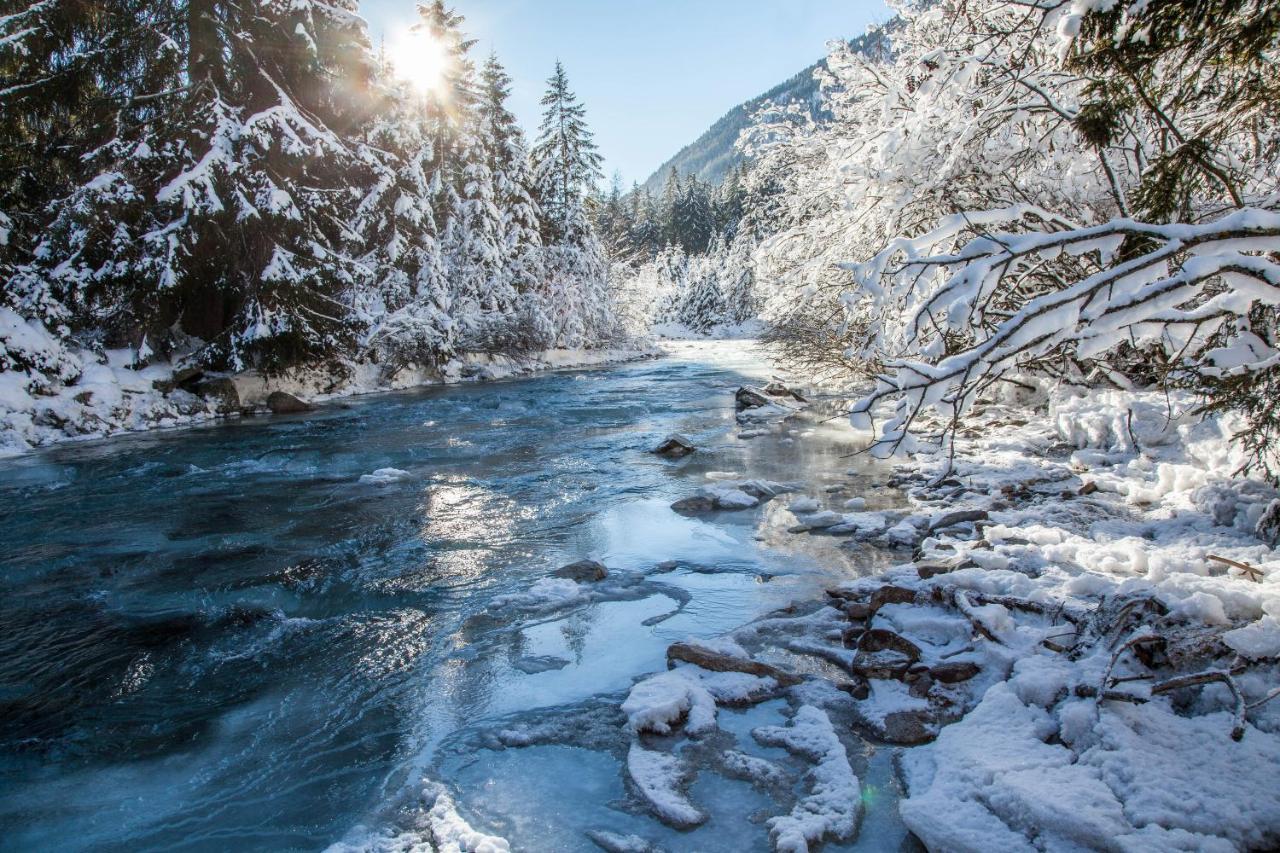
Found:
[846,206,1280,452]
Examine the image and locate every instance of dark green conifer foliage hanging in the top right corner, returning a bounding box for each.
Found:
[1069,0,1280,222]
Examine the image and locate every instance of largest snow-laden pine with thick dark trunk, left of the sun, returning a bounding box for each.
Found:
[7,0,386,369]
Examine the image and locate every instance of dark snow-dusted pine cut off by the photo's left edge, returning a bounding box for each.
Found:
[0,0,183,379]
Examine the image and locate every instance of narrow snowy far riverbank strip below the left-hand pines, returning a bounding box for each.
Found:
[0,345,659,457]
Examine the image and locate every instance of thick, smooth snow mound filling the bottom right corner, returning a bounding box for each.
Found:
[900,684,1280,853]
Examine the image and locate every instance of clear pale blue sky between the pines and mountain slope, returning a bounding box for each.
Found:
[361,0,891,184]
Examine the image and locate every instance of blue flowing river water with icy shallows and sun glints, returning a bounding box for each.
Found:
[0,343,904,850]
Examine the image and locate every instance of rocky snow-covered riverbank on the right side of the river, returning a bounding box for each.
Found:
[581,381,1280,852]
